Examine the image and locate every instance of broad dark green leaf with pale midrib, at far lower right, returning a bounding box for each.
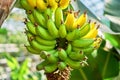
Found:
[95,48,119,78]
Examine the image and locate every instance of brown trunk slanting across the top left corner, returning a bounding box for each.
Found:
[0,0,17,27]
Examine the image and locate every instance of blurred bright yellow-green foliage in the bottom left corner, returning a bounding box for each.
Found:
[5,53,41,80]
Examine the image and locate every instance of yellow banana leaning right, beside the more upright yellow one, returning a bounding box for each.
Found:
[73,12,87,28]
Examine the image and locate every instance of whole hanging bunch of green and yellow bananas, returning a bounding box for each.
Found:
[21,0,102,73]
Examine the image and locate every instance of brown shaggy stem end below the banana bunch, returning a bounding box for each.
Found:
[45,67,71,80]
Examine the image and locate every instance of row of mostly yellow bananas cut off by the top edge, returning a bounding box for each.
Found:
[20,0,70,12]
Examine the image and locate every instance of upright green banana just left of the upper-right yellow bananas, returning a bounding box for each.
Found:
[55,7,64,28]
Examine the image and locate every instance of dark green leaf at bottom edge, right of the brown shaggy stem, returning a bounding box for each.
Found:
[70,55,102,80]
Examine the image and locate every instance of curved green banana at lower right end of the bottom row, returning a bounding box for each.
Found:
[65,57,81,69]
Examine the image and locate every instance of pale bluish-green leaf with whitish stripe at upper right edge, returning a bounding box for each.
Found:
[104,0,120,32]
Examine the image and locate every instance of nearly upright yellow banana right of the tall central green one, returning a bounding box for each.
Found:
[65,11,75,31]
